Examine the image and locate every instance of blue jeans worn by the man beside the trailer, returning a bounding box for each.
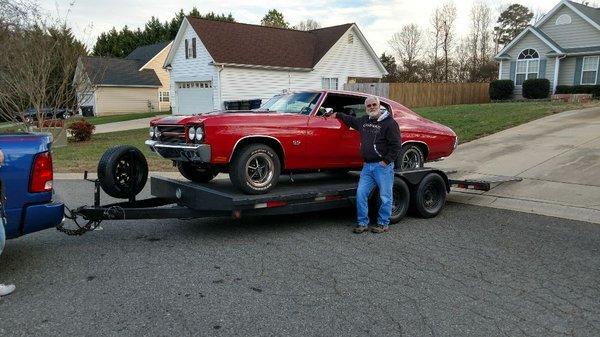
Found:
[356,163,394,227]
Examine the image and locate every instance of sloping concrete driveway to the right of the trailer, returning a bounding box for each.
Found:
[431,108,600,224]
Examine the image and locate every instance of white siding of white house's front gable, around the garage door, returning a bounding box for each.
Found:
[170,25,220,114]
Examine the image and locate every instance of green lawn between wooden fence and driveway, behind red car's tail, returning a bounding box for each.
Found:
[414,102,599,143]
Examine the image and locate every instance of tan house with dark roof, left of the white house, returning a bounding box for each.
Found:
[75,42,171,116]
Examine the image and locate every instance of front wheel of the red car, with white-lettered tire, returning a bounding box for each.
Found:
[229,144,281,194]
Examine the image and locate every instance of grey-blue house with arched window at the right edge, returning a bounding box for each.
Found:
[496,0,600,97]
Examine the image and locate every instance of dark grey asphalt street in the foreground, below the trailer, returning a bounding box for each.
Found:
[0,181,600,336]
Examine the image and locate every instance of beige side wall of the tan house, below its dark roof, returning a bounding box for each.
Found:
[95,87,158,116]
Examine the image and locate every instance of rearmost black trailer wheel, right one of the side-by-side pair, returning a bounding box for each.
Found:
[413,173,446,218]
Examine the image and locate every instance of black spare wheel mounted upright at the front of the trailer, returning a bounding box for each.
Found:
[98,145,148,198]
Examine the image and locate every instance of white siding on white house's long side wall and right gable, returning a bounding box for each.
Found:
[219,28,383,102]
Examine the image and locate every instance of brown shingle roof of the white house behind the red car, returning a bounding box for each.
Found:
[187,16,353,69]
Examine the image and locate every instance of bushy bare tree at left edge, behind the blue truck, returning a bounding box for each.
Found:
[0,0,93,134]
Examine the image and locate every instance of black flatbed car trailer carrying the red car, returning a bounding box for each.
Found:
[58,147,519,235]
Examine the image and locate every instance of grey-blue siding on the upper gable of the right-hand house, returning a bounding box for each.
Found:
[539,5,600,48]
